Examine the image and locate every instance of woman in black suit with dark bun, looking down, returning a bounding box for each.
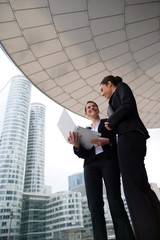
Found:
[100,75,160,240]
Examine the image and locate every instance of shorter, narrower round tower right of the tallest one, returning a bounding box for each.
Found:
[24,103,45,194]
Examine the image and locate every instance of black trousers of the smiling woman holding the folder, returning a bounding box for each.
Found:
[84,153,135,240]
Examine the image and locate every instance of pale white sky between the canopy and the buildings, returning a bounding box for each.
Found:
[0,49,160,193]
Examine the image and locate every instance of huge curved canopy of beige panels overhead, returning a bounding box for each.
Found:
[0,0,160,128]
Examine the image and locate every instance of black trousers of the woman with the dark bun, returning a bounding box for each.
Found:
[118,132,160,240]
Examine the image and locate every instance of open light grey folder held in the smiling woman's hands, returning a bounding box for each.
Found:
[57,109,101,149]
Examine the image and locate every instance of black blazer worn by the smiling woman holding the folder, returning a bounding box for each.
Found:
[73,119,117,165]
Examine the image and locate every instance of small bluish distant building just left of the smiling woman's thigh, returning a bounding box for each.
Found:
[68,173,84,190]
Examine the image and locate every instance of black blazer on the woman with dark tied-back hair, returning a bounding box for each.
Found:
[108,82,149,138]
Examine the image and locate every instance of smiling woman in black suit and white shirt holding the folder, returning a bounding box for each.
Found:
[68,101,135,240]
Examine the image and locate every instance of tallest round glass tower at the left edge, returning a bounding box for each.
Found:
[0,76,31,240]
